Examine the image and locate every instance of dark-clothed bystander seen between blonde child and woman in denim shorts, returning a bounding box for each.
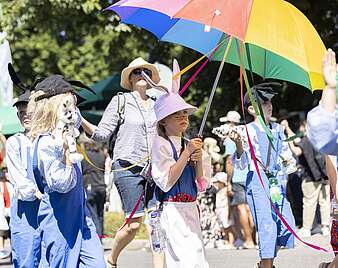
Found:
[80,133,106,238]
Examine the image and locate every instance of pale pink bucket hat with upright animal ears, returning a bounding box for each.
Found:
[142,59,197,122]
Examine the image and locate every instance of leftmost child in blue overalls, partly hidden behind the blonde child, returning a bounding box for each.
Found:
[6,91,41,268]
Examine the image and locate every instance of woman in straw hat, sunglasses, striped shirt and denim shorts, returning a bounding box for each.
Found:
[82,58,163,267]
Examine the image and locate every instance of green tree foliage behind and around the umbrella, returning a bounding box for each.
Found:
[0,0,338,134]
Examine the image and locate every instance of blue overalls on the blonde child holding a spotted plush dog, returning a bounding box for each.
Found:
[33,137,106,268]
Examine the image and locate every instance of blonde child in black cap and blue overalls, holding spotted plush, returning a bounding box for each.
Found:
[28,75,106,268]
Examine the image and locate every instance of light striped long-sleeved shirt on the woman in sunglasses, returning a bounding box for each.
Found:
[92,91,156,166]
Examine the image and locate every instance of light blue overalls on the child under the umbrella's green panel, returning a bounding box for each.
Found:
[246,124,295,259]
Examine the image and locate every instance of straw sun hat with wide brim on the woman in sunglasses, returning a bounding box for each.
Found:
[120,57,160,90]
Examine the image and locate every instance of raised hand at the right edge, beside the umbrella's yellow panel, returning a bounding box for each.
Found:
[323,48,338,89]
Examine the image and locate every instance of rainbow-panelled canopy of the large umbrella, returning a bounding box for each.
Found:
[107,0,326,90]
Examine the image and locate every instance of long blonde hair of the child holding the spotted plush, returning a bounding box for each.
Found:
[27,91,71,139]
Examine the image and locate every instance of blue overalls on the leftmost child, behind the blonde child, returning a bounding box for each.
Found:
[10,136,41,268]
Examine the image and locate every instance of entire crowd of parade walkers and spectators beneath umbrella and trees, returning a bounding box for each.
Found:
[0,50,338,268]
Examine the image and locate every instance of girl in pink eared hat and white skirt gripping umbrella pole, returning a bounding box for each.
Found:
[148,60,209,268]
